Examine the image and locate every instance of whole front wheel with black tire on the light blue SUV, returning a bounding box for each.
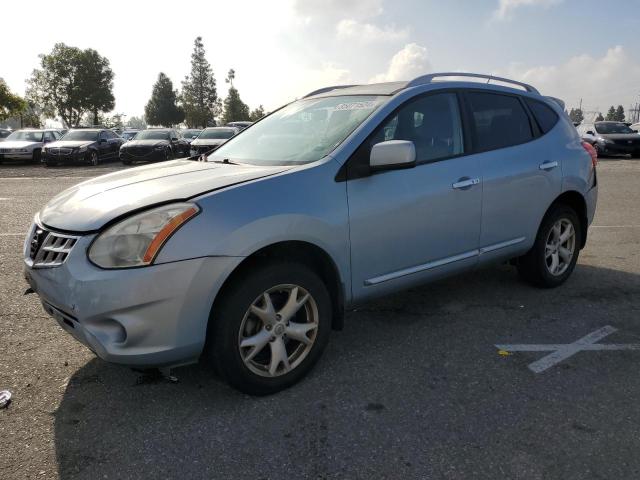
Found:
[205,262,332,395]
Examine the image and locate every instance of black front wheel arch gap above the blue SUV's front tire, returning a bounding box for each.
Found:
[209,240,345,330]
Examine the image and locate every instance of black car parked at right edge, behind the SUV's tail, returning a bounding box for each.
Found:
[578,121,640,156]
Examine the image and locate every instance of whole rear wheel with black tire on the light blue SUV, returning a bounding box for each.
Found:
[517,204,583,288]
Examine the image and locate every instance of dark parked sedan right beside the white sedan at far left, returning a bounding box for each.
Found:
[42,128,124,167]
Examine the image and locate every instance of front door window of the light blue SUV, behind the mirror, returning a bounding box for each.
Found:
[372,93,464,162]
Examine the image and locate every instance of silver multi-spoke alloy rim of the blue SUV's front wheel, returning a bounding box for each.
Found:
[238,284,319,377]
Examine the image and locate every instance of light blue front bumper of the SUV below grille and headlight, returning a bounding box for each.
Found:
[24,235,241,367]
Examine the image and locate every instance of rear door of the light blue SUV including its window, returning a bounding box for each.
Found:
[465,91,562,262]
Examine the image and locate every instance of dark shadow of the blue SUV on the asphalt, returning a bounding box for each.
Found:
[55,265,640,479]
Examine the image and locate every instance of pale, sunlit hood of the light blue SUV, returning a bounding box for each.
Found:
[39,160,292,232]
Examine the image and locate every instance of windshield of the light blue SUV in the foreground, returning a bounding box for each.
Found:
[209,95,387,165]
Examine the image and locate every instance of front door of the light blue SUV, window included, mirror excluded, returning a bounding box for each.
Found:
[347,92,482,300]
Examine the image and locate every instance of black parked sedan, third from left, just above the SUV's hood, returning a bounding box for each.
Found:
[120,128,189,165]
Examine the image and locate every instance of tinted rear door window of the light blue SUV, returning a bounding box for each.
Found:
[467,92,533,152]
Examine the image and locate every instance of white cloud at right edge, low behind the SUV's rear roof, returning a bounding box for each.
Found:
[496,46,640,111]
